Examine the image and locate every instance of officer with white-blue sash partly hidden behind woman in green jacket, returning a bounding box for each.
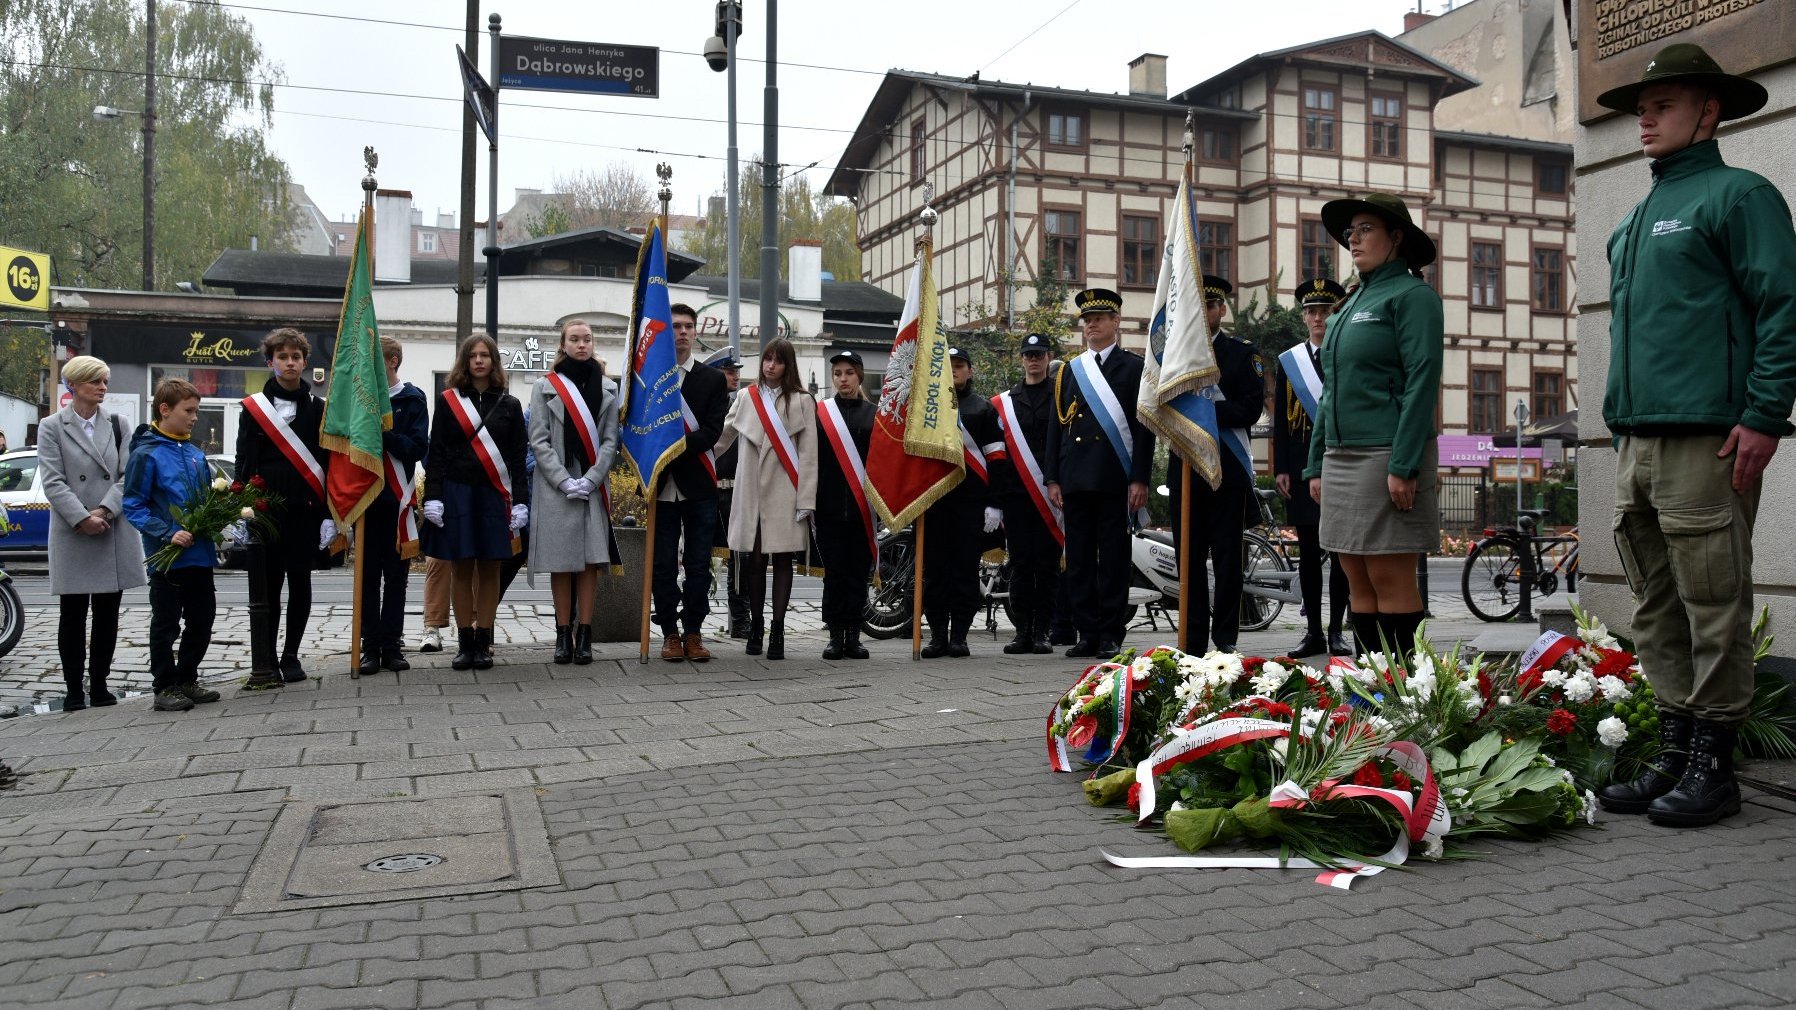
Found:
[1272,277,1352,656]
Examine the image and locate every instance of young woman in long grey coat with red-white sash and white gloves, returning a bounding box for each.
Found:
[530,320,618,665]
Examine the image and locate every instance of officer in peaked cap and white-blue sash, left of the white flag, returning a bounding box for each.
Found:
[1042,288,1153,658]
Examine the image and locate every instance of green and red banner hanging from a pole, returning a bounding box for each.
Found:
[318,210,393,527]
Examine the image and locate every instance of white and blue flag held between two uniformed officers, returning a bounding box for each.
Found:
[1135,162,1223,487]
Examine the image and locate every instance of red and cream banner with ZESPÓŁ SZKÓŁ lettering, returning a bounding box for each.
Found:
[867,231,966,530]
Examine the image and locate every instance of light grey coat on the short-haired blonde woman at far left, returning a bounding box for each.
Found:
[38,406,147,595]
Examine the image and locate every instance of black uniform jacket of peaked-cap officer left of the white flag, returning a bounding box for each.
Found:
[1042,347,1153,494]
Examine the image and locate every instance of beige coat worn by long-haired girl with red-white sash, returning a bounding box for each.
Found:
[717,386,817,554]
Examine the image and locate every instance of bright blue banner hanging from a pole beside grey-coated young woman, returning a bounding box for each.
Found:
[618,221,686,498]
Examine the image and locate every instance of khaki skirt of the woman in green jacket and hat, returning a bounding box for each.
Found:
[1320,439,1440,554]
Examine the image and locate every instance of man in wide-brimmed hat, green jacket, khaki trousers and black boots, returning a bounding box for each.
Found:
[1597,43,1796,825]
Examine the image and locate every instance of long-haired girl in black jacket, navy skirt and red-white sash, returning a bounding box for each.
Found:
[424,332,530,670]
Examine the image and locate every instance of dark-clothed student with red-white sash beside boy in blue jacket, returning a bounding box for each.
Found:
[233,327,336,687]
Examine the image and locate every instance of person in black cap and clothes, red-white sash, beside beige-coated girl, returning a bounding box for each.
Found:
[817,350,875,660]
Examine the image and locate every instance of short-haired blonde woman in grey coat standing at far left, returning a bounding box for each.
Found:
[38,354,145,712]
